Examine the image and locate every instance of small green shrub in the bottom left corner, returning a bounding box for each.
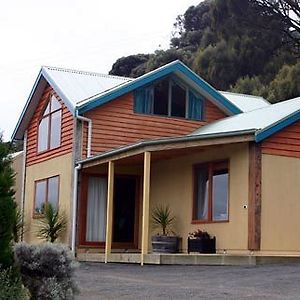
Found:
[0,268,29,300]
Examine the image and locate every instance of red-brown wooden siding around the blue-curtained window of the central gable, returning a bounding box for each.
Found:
[82,93,226,157]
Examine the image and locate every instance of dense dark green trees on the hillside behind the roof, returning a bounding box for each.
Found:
[110,0,300,102]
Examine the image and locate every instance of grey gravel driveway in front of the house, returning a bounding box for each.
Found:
[76,263,300,300]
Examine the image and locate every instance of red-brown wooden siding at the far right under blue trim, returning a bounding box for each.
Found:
[262,122,300,158]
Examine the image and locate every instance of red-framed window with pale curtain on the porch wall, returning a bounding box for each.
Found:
[193,162,229,222]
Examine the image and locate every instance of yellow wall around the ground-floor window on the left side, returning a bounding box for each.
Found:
[24,154,73,243]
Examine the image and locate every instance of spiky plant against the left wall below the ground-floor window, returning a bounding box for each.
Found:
[37,203,67,243]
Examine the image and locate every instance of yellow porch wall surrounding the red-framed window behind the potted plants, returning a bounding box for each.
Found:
[149,143,249,252]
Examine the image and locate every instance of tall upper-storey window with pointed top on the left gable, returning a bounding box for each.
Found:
[38,95,62,152]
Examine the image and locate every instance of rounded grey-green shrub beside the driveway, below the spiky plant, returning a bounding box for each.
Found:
[15,243,78,299]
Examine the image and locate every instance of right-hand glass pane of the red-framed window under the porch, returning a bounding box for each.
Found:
[212,170,228,221]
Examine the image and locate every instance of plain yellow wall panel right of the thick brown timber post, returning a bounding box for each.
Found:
[261,154,300,252]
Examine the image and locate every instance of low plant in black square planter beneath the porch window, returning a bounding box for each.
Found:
[188,229,216,253]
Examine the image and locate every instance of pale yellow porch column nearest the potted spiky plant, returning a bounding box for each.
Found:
[141,152,151,266]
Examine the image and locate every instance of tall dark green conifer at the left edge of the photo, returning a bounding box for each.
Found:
[0,135,16,268]
